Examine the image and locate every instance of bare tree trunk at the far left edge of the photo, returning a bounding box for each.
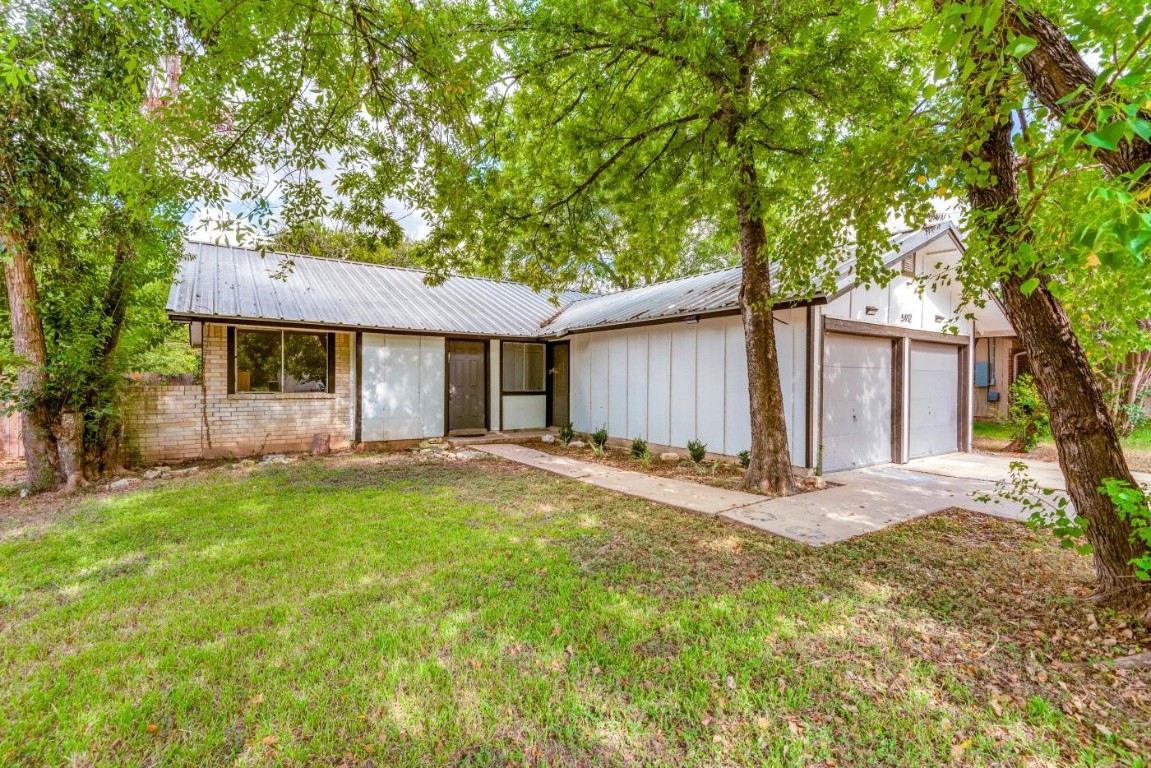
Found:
[0,233,60,491]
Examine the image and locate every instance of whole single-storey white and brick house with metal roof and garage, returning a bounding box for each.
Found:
[127,223,971,471]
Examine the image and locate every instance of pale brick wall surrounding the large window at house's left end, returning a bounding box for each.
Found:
[124,325,352,464]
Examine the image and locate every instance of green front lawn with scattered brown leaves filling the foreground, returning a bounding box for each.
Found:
[0,456,1151,766]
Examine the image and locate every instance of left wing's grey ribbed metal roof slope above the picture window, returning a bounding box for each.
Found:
[167,242,588,337]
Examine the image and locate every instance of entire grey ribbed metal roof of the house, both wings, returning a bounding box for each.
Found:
[167,222,962,337]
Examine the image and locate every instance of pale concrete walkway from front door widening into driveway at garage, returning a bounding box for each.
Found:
[472,444,1026,547]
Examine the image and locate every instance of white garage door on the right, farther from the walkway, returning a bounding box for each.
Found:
[908,341,959,458]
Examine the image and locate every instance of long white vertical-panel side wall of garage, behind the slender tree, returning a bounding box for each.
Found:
[571,310,807,465]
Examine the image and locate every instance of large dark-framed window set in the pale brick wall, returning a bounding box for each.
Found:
[235,328,333,393]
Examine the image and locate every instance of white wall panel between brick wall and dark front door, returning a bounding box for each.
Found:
[360,333,445,442]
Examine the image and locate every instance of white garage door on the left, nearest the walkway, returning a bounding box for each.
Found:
[823,334,891,472]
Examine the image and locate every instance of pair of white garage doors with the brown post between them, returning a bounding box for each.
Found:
[820,332,967,472]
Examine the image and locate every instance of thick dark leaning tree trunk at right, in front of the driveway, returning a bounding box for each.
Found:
[968,120,1151,614]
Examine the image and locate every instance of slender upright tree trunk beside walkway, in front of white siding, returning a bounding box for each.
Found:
[727,121,795,496]
